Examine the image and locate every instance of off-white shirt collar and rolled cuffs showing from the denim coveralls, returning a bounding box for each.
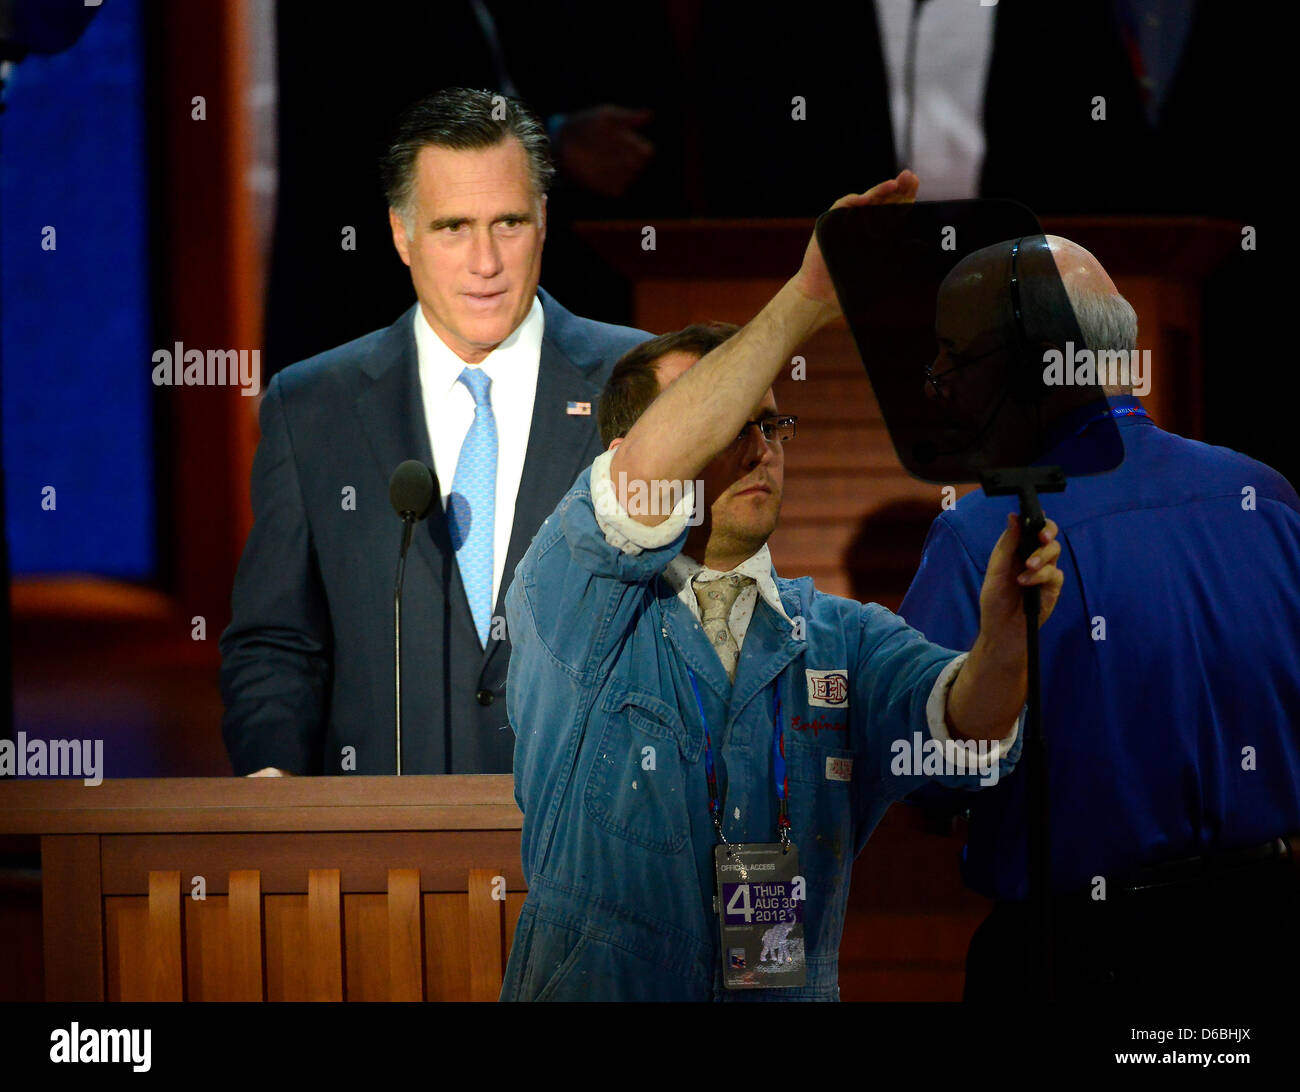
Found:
[592,451,1021,762]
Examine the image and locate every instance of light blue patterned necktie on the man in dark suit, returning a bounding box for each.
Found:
[447,368,497,647]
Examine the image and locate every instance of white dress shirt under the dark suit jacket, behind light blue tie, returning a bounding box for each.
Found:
[415,296,545,610]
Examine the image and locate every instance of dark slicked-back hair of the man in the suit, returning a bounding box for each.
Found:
[380,87,555,225]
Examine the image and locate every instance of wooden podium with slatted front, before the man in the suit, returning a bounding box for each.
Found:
[0,775,524,1001]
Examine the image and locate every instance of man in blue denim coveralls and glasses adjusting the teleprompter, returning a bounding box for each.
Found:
[502,172,1061,1001]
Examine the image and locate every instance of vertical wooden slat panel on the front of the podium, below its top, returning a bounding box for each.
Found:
[104,868,524,1001]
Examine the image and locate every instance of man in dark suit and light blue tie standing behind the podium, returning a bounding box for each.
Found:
[221,88,649,775]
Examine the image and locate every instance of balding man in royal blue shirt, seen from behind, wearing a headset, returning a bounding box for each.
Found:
[900,237,1300,1000]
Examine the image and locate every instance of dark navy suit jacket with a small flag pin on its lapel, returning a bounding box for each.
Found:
[221,290,660,775]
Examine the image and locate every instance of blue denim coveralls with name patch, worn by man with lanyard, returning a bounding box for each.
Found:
[502,468,1021,1001]
